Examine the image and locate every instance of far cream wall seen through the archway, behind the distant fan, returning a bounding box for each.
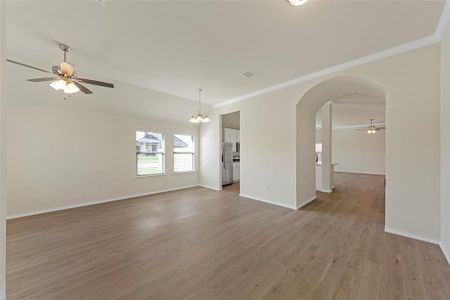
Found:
[332,128,385,175]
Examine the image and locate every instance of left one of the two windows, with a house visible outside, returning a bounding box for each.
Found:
[136,131,164,176]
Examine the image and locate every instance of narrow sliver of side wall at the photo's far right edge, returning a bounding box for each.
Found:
[441,18,450,262]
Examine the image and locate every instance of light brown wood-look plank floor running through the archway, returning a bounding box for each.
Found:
[7,173,450,300]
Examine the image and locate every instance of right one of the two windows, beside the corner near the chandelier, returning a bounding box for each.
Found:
[173,134,195,172]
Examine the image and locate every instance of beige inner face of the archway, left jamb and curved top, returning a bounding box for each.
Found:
[296,75,386,207]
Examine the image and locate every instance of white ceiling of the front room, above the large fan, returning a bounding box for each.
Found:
[7,0,444,104]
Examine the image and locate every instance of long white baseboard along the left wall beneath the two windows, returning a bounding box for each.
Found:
[6,184,199,220]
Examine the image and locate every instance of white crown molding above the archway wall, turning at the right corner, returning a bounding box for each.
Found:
[212,0,450,109]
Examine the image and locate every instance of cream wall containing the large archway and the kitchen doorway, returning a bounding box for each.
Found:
[201,44,440,241]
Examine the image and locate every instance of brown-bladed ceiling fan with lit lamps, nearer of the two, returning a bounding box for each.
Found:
[7,44,114,94]
